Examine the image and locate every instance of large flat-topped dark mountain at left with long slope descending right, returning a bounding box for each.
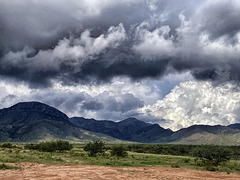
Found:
[0,102,121,142]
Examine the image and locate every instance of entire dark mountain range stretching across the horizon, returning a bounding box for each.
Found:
[0,102,240,145]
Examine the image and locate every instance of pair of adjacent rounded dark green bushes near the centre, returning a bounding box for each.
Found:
[83,140,128,158]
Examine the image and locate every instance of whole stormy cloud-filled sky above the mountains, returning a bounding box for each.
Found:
[0,0,240,130]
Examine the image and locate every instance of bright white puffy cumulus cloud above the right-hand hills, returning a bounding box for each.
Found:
[141,81,240,130]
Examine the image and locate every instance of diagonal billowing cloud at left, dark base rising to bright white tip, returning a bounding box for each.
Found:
[0,24,125,86]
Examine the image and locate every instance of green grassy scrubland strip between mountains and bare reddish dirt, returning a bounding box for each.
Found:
[0,141,240,173]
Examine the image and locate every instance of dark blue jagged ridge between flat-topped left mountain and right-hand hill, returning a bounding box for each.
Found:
[69,117,173,143]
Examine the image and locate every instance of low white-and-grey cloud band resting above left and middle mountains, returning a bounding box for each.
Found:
[0,82,144,120]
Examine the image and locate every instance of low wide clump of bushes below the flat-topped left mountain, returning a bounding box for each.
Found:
[24,140,73,152]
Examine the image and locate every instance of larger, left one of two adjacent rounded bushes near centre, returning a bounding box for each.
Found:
[83,140,105,157]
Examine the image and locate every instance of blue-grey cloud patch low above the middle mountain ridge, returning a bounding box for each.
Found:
[80,91,144,120]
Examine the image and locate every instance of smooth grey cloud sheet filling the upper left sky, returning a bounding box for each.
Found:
[0,0,149,52]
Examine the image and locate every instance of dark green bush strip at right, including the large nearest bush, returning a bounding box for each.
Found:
[126,144,240,171]
